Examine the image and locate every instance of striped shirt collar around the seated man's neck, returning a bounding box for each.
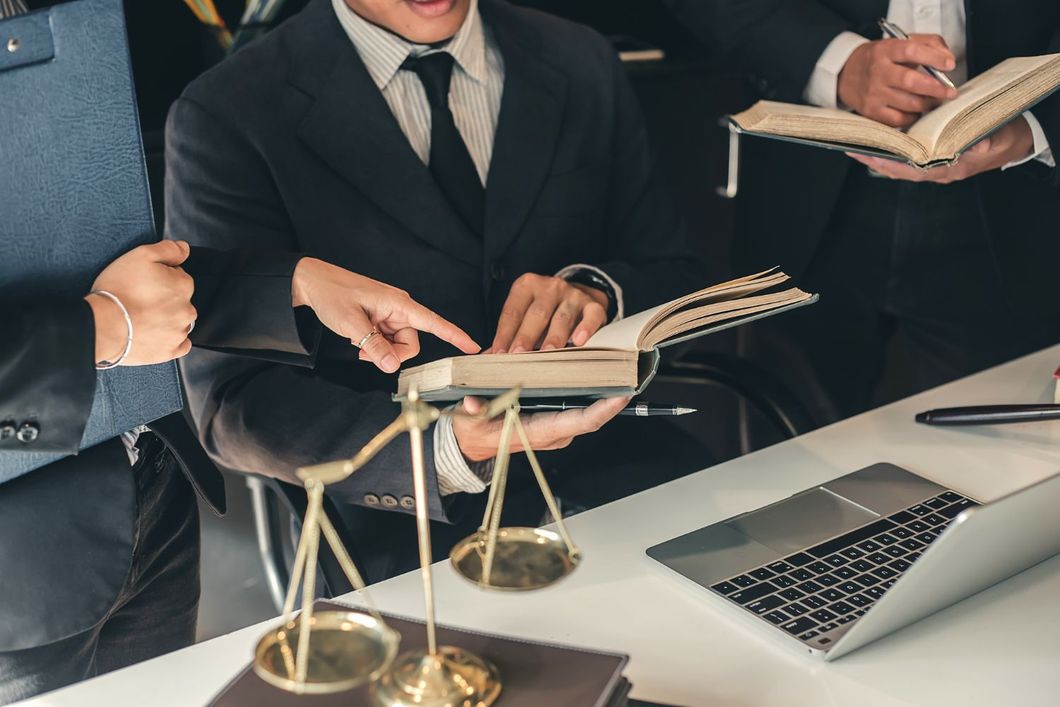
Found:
[332,0,487,91]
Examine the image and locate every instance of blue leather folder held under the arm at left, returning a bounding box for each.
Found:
[0,0,181,483]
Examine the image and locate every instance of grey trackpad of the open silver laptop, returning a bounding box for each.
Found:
[725,488,880,554]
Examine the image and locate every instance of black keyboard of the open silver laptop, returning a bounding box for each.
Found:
[710,491,978,648]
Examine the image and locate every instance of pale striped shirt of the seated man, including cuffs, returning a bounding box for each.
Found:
[332,0,623,496]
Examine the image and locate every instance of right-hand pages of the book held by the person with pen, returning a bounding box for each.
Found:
[908,54,1060,158]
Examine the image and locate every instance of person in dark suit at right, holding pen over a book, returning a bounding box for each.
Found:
[667,0,1060,423]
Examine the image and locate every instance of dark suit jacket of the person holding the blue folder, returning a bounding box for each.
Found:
[0,248,318,651]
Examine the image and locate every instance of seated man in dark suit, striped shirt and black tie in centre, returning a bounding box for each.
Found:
[166,0,706,578]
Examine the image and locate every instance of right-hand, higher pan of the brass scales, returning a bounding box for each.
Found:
[449,528,581,591]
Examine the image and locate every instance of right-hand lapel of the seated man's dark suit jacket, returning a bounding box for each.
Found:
[480,2,567,259]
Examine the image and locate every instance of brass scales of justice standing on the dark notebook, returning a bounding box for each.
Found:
[253,388,581,707]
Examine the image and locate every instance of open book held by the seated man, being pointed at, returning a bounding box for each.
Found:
[396,268,817,401]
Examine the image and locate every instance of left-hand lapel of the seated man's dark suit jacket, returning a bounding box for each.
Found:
[293,2,482,266]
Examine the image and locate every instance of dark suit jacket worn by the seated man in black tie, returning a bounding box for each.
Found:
[166,0,703,518]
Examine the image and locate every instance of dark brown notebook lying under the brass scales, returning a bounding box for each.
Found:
[212,603,630,707]
